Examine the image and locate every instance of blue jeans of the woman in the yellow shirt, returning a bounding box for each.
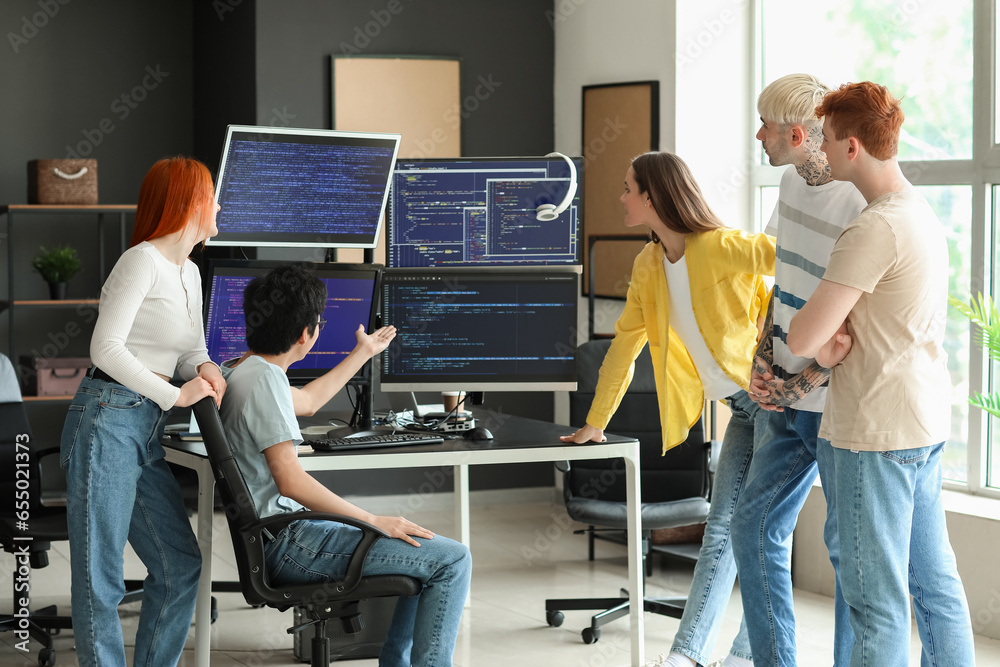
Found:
[670,390,761,664]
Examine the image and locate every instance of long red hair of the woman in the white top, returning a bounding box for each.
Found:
[129,157,215,248]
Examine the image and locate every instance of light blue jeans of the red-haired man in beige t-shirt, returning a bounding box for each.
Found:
[834,443,976,667]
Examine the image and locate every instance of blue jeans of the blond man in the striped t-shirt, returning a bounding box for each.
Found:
[733,408,854,667]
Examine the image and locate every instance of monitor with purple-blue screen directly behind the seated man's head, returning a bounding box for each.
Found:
[205,259,382,382]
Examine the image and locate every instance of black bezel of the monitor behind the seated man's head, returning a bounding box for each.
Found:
[202,259,384,384]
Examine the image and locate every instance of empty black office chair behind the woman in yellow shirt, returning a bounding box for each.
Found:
[545,339,719,644]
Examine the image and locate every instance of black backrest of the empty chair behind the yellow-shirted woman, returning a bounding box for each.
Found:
[564,339,710,503]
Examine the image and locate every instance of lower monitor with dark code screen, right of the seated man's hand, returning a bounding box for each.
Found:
[379,267,580,391]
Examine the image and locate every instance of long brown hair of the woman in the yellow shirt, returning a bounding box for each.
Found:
[632,152,726,243]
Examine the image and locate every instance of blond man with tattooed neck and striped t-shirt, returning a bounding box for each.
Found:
[732,74,865,667]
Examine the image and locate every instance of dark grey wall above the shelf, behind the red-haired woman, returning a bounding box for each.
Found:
[0,0,193,204]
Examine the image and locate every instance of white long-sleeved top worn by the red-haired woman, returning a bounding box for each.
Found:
[90,241,211,410]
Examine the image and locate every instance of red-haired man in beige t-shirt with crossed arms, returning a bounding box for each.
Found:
[784,81,976,667]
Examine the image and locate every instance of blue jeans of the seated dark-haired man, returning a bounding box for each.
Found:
[264,521,472,667]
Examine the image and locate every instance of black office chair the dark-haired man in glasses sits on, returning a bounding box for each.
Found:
[194,398,423,667]
